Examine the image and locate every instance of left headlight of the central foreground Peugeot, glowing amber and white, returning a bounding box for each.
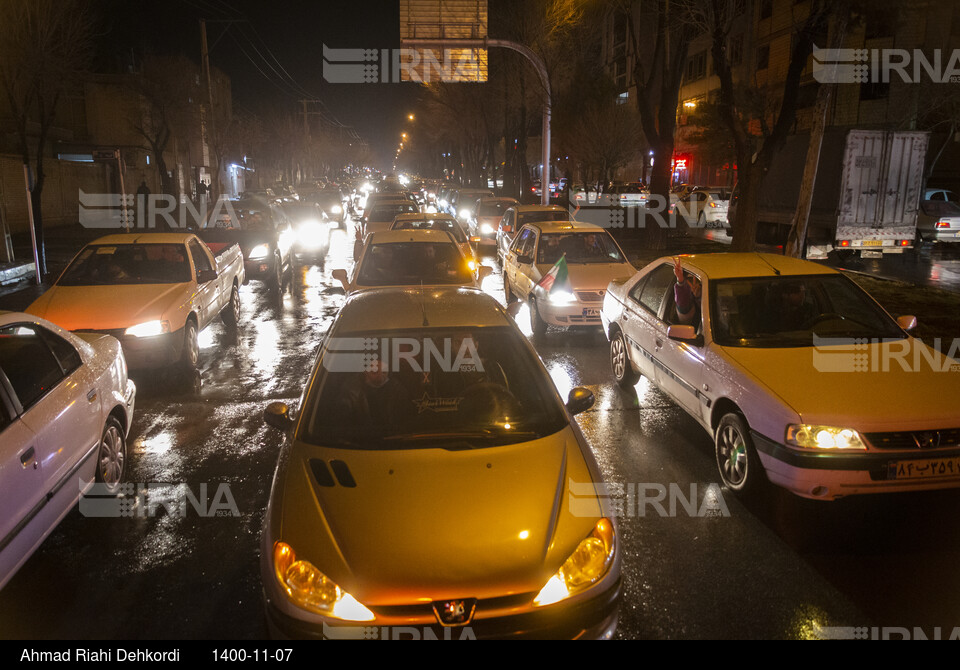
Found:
[273,542,375,621]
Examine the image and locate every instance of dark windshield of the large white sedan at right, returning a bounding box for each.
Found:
[710,275,905,347]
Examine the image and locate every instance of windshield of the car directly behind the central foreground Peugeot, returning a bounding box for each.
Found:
[357,242,473,286]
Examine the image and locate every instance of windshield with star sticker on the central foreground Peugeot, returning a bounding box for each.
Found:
[297,327,566,450]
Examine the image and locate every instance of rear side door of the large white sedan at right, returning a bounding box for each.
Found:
[621,263,675,382]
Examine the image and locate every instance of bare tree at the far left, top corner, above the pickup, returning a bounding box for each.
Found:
[0,0,94,274]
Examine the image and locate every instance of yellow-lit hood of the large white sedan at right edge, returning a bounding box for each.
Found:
[723,338,960,432]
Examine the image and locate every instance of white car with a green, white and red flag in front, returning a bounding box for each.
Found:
[503,221,636,336]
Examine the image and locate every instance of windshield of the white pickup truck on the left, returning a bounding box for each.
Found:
[57,244,191,286]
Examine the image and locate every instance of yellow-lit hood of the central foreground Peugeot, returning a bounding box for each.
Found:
[275,427,601,606]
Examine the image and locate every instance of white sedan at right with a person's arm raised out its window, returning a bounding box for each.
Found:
[602,253,960,500]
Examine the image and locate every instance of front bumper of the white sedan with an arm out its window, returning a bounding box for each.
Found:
[752,432,960,500]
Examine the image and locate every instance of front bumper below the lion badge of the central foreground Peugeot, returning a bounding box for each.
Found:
[264,576,622,640]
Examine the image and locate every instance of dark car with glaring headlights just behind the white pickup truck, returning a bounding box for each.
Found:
[199,203,296,291]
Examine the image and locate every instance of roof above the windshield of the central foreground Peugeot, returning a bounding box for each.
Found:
[331,286,512,337]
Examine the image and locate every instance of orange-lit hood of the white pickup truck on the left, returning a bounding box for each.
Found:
[27,282,192,330]
